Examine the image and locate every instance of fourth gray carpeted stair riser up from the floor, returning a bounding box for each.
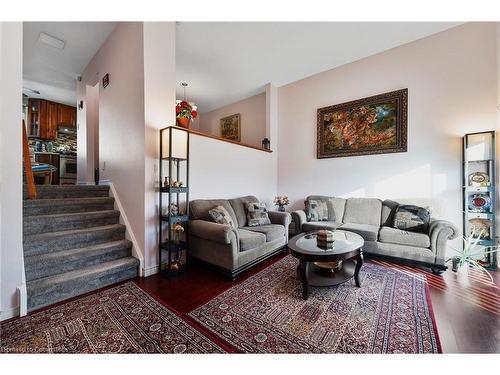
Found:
[23,212,120,235]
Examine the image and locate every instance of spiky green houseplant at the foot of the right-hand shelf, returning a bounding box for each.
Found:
[446,229,498,282]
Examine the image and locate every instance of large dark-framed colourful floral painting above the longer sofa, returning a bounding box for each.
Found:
[317,89,408,159]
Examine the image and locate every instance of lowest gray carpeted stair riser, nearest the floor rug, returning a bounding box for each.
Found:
[28,267,137,312]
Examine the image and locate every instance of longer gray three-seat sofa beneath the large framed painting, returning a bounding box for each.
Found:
[292,195,458,273]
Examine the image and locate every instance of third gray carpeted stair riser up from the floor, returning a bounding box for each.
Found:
[24,227,125,256]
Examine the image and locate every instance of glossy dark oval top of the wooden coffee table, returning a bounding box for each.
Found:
[288,230,365,256]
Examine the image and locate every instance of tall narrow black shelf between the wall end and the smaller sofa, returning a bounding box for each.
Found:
[158,126,189,277]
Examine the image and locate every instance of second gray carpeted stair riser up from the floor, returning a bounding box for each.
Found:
[25,247,132,281]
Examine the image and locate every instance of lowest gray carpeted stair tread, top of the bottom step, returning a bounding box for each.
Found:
[26,256,139,293]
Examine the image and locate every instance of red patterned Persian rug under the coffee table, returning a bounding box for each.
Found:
[189,256,441,353]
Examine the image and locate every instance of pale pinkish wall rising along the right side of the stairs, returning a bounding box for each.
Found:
[77,22,145,251]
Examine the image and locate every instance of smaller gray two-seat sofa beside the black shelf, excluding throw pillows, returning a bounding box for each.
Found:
[189,196,292,277]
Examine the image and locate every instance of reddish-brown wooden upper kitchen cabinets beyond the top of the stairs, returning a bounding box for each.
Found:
[28,98,76,140]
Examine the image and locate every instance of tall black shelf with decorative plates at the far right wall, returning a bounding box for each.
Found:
[464,131,498,269]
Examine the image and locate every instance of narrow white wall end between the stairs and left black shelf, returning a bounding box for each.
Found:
[144,22,176,269]
